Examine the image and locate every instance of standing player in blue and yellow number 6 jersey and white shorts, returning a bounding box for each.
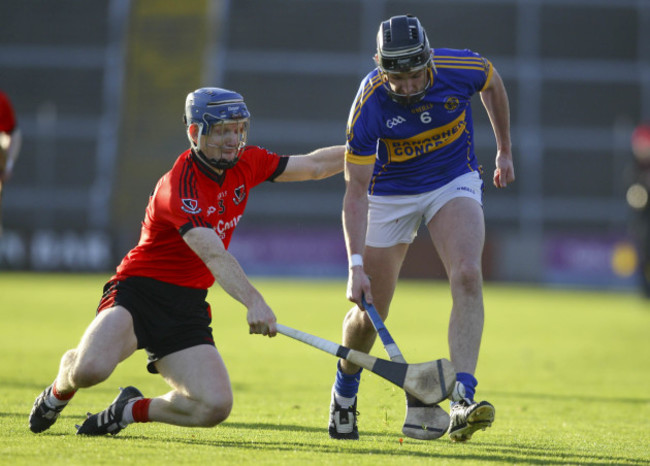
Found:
[329,15,515,441]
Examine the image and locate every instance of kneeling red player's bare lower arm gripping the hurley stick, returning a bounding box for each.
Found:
[183,227,277,337]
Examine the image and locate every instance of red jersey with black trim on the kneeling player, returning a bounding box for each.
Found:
[114,146,288,289]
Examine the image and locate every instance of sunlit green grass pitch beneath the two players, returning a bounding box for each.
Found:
[0,272,650,465]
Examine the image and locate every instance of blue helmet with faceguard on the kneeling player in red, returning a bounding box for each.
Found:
[183,87,250,170]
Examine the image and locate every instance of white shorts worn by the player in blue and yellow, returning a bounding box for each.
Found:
[366,172,483,248]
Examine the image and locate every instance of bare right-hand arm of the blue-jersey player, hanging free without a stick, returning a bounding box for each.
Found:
[481,68,515,188]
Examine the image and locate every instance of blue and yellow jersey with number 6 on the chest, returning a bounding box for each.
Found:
[345,49,492,196]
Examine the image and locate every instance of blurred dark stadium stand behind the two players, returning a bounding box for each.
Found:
[0,0,650,288]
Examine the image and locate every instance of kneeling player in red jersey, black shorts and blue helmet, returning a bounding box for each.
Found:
[29,88,344,435]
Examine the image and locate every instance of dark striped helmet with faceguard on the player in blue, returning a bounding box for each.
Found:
[376,15,433,105]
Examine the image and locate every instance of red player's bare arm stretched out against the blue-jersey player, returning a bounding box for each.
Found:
[275,146,345,181]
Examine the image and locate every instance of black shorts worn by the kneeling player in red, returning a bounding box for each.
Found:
[97,277,214,374]
